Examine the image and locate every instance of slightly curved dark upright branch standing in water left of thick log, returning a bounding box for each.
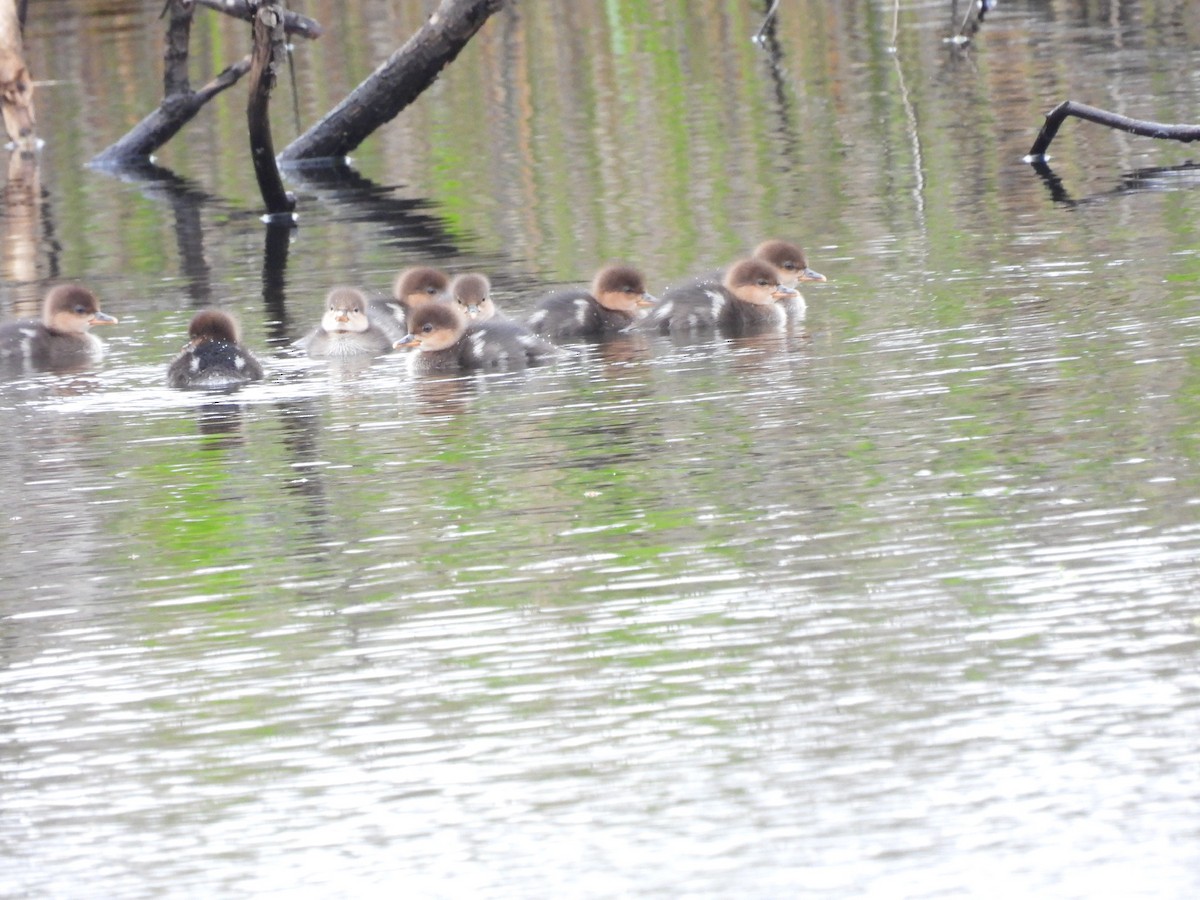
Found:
[246,0,296,216]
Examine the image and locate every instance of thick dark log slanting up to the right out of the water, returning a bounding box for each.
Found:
[280,0,504,164]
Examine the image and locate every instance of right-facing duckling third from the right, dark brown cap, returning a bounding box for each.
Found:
[527,265,655,340]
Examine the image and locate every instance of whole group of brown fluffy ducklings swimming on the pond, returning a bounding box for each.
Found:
[0,240,826,389]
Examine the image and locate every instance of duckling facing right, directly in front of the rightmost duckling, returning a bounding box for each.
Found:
[643,259,797,335]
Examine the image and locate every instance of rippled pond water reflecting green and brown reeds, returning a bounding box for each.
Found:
[0,0,1200,898]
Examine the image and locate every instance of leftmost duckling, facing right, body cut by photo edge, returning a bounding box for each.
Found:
[0,284,116,370]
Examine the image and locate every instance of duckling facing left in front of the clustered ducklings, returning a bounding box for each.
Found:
[396,304,560,374]
